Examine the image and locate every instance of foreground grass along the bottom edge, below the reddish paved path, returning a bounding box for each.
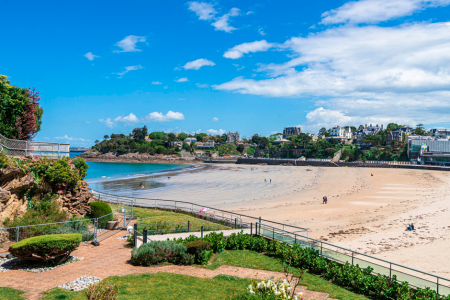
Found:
[40,273,251,300]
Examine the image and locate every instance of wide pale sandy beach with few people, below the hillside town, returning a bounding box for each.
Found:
[136,165,450,277]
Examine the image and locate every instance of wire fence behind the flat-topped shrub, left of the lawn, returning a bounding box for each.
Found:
[0,201,133,254]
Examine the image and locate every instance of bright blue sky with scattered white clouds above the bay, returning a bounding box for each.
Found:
[0,0,450,146]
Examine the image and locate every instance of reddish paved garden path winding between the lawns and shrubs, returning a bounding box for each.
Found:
[0,231,328,300]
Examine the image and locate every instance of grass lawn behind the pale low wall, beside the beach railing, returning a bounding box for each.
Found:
[110,204,230,231]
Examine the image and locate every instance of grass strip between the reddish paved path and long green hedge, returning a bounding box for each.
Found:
[204,250,368,300]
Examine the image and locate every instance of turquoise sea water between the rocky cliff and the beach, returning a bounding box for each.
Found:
[70,152,192,197]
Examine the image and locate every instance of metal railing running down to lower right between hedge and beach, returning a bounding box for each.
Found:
[256,223,450,295]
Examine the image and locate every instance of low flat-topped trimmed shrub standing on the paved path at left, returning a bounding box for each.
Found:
[9,233,81,263]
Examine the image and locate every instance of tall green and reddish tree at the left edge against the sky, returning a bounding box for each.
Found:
[0,75,44,140]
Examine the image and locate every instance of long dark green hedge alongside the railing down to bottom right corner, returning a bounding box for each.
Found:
[176,232,450,300]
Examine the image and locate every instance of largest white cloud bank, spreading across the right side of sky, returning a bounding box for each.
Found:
[213,23,450,127]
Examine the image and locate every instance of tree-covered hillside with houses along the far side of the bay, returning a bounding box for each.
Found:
[91,123,450,165]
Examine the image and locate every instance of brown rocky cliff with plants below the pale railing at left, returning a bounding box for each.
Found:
[0,160,94,226]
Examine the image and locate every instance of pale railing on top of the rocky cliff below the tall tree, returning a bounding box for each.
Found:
[0,134,70,158]
